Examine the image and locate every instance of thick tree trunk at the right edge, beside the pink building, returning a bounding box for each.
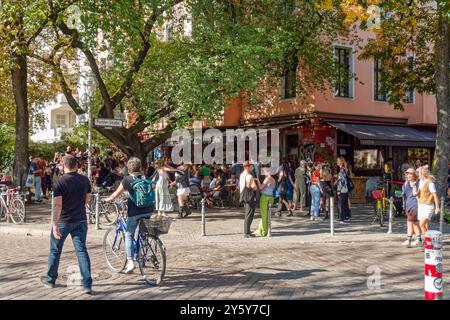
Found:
[433,11,450,197]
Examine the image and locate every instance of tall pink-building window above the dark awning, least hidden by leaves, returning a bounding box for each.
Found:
[334,47,353,98]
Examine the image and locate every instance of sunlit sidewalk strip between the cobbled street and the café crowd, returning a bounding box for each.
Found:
[0,201,450,244]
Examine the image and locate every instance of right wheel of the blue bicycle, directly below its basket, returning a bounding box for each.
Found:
[138,236,166,285]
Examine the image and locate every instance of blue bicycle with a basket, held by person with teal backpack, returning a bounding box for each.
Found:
[103,215,173,285]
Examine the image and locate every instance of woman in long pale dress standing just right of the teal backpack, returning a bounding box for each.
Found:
[155,161,177,217]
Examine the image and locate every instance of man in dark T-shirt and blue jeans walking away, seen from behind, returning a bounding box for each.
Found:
[41,155,92,294]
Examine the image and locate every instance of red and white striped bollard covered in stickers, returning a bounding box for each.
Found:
[424,230,444,300]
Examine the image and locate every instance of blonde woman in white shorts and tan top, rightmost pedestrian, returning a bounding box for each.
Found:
[417,166,440,240]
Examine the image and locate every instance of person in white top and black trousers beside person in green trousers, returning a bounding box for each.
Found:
[239,161,256,238]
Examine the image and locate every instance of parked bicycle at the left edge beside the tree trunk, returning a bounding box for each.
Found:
[0,186,26,224]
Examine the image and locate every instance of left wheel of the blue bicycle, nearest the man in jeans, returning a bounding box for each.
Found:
[103,228,127,273]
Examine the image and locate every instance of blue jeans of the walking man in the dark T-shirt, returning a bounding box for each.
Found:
[47,221,92,287]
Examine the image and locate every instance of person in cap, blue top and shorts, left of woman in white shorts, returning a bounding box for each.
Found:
[402,168,422,248]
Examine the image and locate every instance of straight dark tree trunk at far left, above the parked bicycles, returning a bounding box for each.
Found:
[11,54,29,188]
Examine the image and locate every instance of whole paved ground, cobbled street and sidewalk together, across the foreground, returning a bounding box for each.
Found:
[0,202,450,300]
